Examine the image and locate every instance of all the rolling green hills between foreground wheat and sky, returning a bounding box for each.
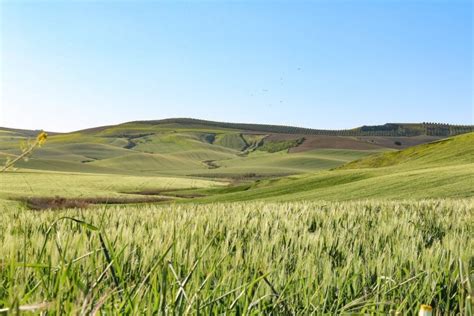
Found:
[0,119,474,203]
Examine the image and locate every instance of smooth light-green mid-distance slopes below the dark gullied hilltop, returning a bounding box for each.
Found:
[0,140,374,176]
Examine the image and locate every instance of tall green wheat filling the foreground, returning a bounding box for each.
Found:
[0,199,474,315]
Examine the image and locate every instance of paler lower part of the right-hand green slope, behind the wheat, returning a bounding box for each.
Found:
[194,164,474,202]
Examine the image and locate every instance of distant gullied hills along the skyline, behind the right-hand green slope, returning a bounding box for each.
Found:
[0,119,463,179]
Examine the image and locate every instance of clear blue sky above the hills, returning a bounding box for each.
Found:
[0,0,473,131]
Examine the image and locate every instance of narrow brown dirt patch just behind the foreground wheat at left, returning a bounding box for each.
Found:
[18,196,169,210]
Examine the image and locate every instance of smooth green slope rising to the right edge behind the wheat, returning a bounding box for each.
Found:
[196,133,474,202]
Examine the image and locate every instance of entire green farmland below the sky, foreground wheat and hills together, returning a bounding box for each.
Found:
[0,121,474,315]
